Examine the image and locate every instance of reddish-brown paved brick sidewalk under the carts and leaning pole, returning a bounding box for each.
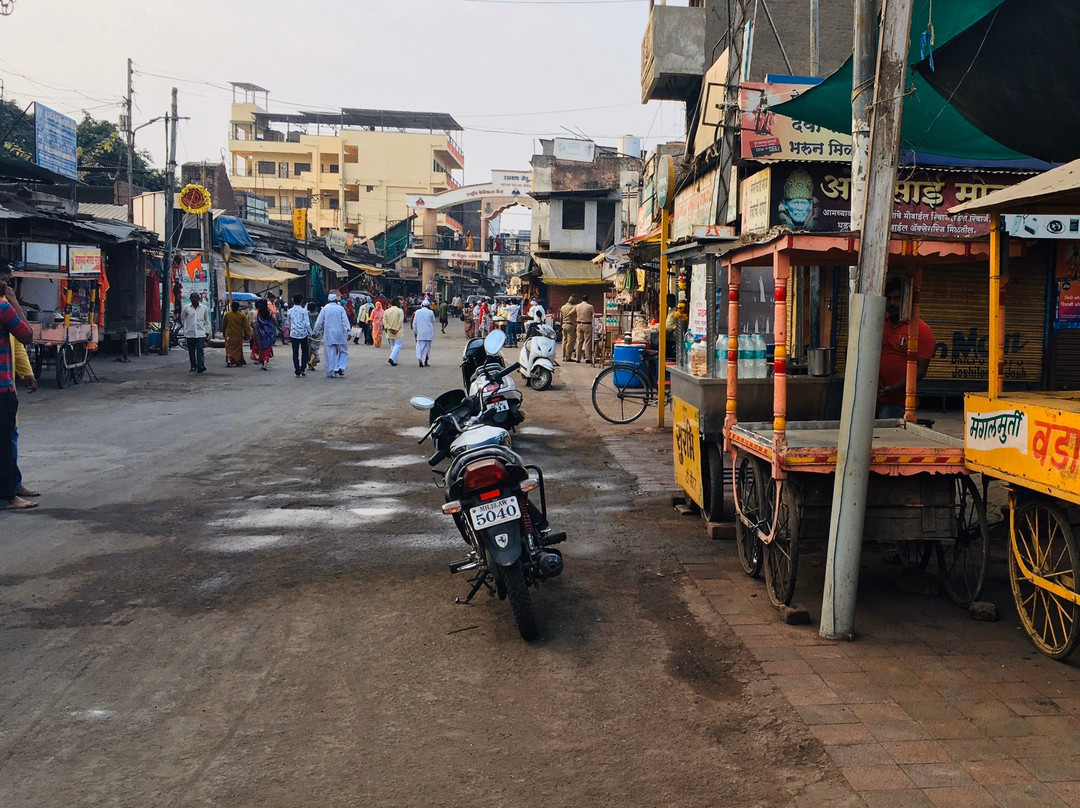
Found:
[563,356,1080,808]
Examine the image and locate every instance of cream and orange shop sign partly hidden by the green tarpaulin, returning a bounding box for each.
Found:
[739,76,851,162]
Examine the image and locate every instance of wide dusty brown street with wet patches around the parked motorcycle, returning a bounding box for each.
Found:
[0,337,863,808]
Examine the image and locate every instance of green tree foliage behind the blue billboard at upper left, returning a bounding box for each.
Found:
[0,100,165,191]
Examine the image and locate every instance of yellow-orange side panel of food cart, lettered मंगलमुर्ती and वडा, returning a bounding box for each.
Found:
[963,392,1080,503]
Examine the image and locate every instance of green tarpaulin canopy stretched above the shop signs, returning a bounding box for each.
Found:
[773,0,1028,160]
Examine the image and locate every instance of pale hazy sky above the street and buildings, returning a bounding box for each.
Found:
[0,0,684,197]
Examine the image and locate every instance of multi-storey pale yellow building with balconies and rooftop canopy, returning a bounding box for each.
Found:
[229,82,464,239]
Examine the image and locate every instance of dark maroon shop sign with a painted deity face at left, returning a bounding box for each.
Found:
[755,163,1023,241]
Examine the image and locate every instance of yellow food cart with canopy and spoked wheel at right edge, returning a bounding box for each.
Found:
[954,187,1080,659]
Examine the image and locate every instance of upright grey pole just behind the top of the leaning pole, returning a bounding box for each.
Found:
[851,0,880,230]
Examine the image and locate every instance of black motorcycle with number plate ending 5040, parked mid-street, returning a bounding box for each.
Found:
[411,332,566,641]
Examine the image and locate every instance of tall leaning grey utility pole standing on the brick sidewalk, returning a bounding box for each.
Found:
[819,0,913,639]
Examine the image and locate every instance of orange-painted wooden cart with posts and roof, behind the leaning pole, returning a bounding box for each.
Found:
[724,234,989,605]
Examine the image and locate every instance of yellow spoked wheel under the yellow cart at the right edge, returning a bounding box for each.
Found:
[1009,499,1080,659]
